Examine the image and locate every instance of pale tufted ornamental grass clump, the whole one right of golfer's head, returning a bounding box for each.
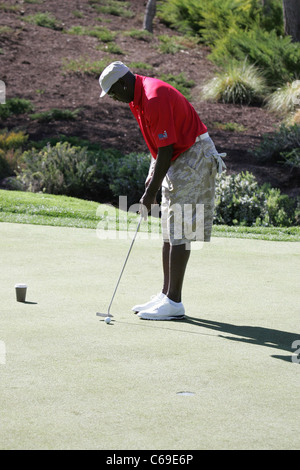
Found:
[202,62,266,104]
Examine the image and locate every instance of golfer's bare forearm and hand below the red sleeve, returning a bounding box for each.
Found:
[140,145,173,218]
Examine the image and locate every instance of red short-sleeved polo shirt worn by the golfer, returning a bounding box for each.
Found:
[129,75,207,160]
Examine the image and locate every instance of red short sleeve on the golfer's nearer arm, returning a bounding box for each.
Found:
[145,96,177,148]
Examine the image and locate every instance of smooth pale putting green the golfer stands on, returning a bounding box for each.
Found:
[0,223,300,450]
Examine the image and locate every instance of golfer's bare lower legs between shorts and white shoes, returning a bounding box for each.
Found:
[163,242,190,302]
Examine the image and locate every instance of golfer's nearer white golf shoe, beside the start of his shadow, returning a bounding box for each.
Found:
[138,296,185,320]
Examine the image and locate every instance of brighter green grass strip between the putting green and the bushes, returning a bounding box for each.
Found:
[0,190,300,241]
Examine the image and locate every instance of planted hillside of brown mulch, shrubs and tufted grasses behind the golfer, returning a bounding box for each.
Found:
[0,0,300,226]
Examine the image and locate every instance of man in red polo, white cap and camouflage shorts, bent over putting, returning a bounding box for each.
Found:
[99,61,226,320]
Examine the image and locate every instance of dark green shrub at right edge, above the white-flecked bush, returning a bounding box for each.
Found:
[253,124,300,168]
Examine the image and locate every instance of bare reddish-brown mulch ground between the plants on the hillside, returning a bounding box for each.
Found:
[0,0,299,196]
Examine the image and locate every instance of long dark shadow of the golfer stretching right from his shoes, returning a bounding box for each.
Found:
[183,316,300,364]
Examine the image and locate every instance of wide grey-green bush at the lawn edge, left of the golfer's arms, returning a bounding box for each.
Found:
[17,142,149,205]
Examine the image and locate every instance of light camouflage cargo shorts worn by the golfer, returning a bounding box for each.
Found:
[161,138,217,245]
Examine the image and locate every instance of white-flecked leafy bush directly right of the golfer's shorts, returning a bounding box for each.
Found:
[214,172,297,227]
